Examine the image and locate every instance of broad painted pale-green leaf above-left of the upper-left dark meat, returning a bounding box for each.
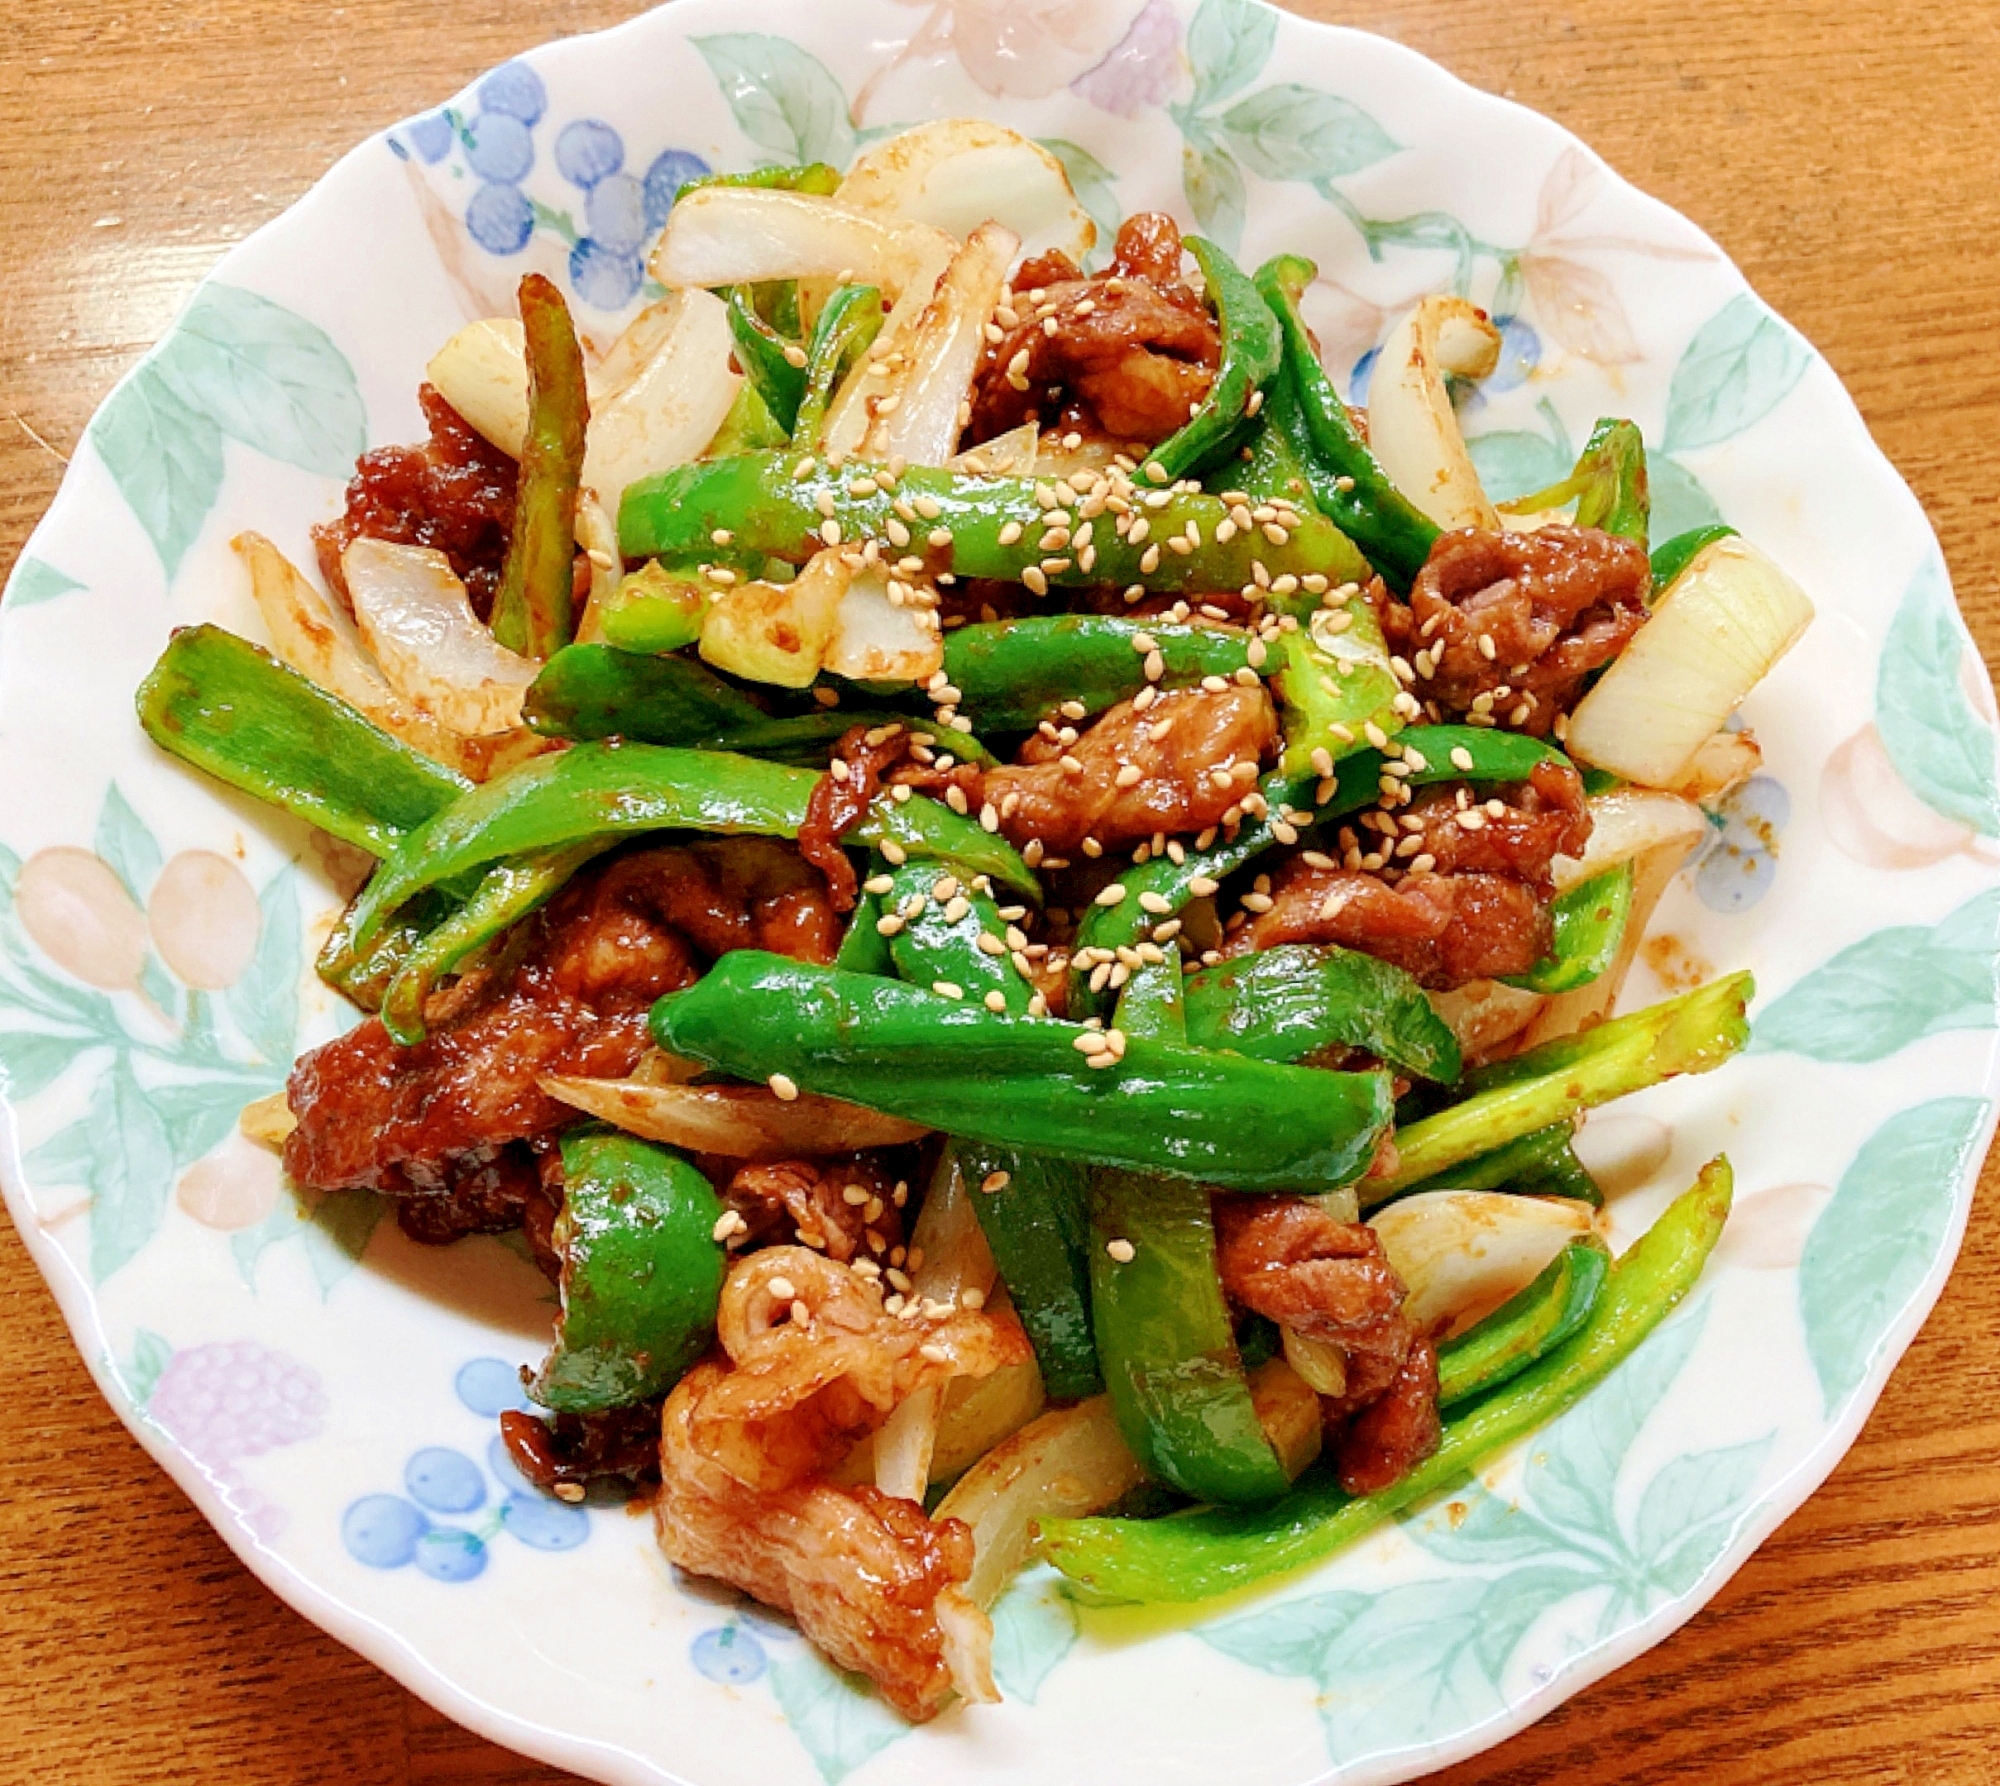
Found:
[152,284,368,478]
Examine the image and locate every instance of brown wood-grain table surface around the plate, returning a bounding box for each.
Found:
[0,0,2000,1786]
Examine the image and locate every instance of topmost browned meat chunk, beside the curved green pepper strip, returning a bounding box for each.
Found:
[966,212,1220,444]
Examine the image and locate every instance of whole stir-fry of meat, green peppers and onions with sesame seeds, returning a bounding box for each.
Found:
[129,120,1812,1718]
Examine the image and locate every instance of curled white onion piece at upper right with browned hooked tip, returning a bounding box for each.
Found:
[1368,298,1500,532]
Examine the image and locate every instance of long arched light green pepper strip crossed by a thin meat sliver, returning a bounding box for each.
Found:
[340,742,1040,948]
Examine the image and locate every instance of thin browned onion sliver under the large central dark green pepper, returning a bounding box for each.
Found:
[540,1074,930,1160]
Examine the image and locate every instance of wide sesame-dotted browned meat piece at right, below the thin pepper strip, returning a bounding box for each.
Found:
[1228,764,1590,990]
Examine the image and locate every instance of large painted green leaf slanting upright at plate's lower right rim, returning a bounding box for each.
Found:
[1798,1098,1986,1416]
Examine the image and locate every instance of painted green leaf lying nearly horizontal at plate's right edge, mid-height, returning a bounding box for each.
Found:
[1750,890,2000,1062]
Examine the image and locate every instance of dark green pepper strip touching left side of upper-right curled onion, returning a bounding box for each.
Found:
[1256,254,1438,588]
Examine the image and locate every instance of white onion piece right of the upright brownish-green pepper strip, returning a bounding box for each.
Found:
[584,292,742,516]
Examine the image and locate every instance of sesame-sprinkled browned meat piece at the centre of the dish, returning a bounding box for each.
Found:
[982,684,1278,854]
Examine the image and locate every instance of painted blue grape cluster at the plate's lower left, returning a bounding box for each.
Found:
[340,1358,590,1582]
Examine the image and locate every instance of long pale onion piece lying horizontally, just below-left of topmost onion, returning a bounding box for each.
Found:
[652,186,958,298]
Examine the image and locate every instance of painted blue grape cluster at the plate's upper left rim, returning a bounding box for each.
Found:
[398,62,710,310]
